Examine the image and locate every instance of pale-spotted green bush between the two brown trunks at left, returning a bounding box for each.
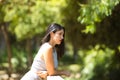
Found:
[11,46,27,72]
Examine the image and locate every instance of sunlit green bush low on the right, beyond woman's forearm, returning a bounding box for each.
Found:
[61,45,116,80]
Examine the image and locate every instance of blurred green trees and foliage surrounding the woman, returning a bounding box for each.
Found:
[0,0,120,80]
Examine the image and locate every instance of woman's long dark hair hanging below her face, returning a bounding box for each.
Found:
[41,23,65,60]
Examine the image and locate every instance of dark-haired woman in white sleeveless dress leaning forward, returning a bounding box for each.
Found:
[21,23,70,80]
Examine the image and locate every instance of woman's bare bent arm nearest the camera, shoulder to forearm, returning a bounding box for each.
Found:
[43,46,70,76]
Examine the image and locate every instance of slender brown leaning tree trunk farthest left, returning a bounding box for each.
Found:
[1,26,12,77]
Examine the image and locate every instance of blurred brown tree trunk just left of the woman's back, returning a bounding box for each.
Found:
[26,39,32,67]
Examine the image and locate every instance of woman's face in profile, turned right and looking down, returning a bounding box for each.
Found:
[53,29,64,44]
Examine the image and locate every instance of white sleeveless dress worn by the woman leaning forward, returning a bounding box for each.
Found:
[21,43,63,80]
